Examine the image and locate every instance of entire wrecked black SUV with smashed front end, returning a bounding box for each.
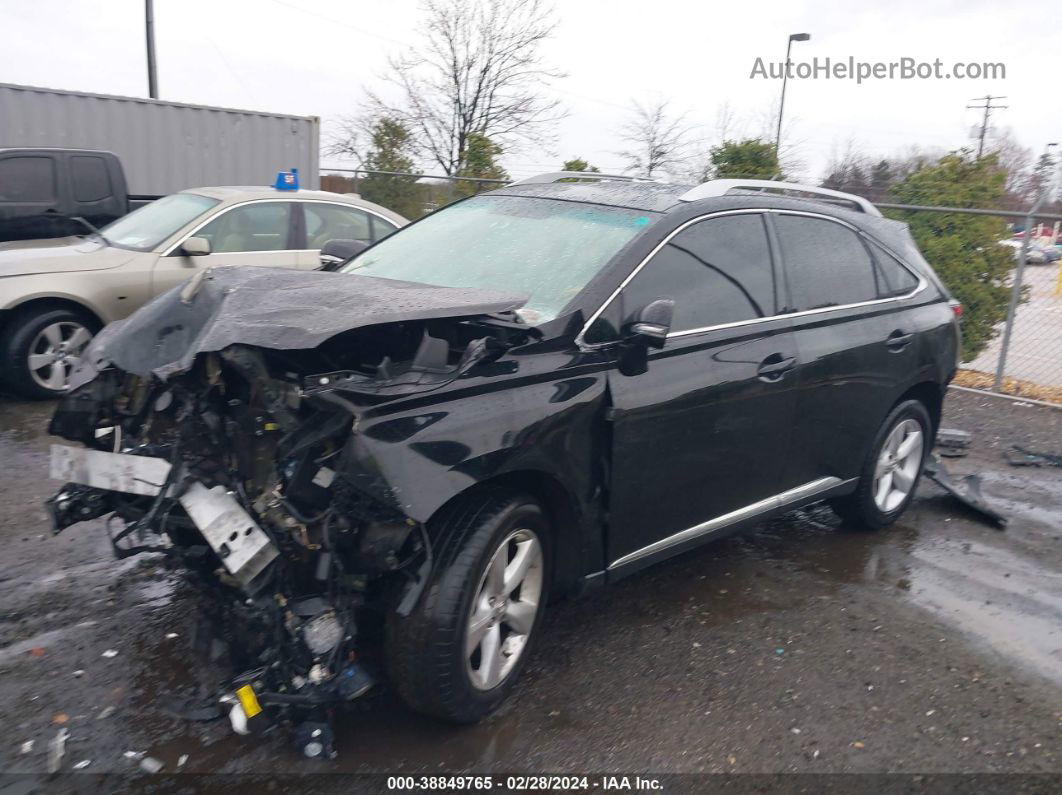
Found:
[50,174,958,753]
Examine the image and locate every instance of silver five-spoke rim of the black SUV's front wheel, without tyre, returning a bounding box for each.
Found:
[465,530,543,690]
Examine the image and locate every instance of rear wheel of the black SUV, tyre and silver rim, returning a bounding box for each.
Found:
[830,400,932,530]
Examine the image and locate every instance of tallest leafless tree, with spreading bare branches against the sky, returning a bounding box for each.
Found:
[369,0,564,175]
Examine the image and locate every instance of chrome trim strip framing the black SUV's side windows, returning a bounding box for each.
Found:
[576,207,928,350]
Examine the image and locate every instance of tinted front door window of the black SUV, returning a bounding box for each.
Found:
[623,214,774,331]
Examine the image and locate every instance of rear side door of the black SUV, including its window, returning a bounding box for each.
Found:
[771,211,911,483]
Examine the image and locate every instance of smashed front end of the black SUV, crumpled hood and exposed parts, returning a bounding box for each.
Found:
[48,269,528,756]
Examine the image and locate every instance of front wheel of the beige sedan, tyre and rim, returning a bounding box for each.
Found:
[0,309,96,400]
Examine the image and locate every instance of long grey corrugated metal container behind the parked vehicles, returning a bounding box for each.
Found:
[0,83,321,196]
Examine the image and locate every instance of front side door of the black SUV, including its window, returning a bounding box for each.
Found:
[607,212,797,569]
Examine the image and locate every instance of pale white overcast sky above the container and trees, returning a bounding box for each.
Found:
[0,0,1062,180]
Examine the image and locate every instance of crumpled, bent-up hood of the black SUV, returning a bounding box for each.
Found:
[71,266,527,386]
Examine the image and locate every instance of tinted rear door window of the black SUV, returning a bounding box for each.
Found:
[774,213,877,312]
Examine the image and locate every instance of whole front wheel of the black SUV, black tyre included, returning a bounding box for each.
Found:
[386,489,550,723]
